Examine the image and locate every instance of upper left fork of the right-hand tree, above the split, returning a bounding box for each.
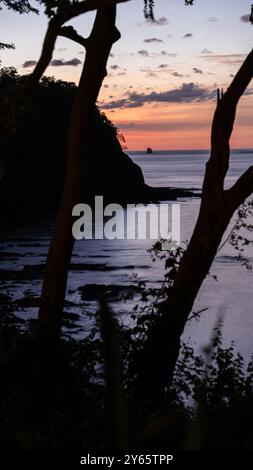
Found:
[203,50,253,194]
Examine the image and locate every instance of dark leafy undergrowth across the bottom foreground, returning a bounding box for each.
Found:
[0,302,253,450]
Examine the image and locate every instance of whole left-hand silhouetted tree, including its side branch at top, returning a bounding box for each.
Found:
[36,0,202,343]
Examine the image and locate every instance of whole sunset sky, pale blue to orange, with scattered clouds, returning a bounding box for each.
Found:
[0,0,253,150]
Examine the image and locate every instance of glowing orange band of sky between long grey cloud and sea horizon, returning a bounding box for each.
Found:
[106,96,253,150]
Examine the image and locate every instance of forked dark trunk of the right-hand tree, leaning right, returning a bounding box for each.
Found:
[136,48,253,401]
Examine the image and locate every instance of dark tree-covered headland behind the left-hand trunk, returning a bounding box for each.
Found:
[0,68,138,217]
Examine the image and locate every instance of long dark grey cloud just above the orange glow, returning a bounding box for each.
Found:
[103,82,215,109]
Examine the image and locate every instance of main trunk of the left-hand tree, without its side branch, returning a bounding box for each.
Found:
[38,6,120,349]
